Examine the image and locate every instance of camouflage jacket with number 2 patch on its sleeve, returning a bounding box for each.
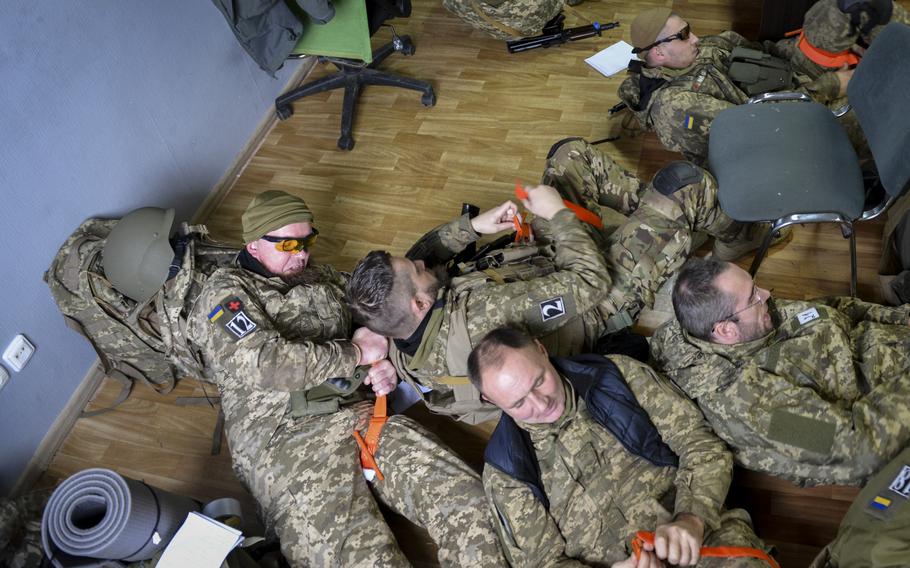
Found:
[389,210,611,423]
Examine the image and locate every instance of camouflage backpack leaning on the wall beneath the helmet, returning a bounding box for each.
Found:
[44,219,238,416]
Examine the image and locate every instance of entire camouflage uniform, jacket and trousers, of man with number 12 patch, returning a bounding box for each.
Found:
[187,260,501,566]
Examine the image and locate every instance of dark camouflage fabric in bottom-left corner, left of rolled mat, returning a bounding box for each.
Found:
[0,489,51,568]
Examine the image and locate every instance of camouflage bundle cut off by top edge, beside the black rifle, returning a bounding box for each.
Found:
[442,0,565,40]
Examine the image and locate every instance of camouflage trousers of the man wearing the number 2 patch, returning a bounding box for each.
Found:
[543,140,744,318]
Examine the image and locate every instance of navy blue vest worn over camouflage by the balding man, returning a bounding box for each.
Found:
[484,355,679,508]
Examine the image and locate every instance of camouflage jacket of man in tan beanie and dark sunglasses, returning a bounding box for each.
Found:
[619,31,840,165]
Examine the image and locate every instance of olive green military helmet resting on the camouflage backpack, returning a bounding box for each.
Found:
[101,207,174,303]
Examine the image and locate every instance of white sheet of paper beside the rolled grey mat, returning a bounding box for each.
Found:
[158,512,243,568]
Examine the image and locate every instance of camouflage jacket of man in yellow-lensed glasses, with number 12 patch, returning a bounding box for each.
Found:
[187,260,358,476]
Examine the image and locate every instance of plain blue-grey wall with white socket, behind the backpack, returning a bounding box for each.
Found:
[0,0,293,495]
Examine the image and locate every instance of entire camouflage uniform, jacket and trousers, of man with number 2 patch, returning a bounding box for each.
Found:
[389,140,742,422]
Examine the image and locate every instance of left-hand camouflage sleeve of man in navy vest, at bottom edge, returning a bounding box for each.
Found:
[483,465,587,568]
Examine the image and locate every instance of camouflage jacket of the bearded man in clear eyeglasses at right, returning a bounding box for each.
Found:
[651,298,910,485]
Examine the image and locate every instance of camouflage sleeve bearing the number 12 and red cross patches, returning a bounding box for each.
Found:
[187,281,359,391]
